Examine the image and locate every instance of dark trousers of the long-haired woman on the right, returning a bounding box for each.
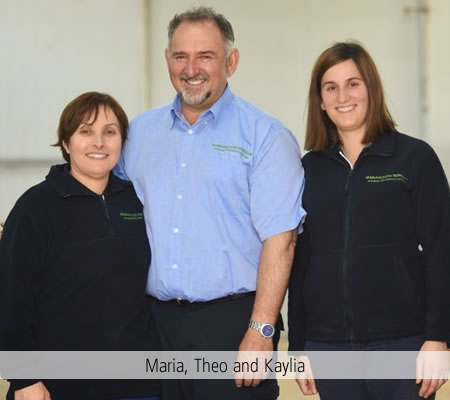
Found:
[305,336,435,400]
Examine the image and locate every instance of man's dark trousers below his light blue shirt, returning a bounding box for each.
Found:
[152,295,280,400]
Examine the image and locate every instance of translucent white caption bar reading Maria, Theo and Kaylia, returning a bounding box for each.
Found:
[0,351,450,379]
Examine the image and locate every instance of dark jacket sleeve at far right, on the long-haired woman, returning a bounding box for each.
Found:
[413,147,450,342]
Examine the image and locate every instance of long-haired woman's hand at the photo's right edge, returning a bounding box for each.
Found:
[416,340,449,398]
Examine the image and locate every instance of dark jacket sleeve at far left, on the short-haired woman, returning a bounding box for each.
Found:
[0,199,46,390]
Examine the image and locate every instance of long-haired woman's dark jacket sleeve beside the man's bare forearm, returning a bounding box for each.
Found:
[288,228,310,352]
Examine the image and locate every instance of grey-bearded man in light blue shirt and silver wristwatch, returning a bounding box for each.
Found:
[116,7,305,400]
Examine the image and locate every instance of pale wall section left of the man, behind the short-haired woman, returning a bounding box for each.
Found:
[0,0,147,220]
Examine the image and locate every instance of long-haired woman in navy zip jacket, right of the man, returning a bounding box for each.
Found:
[289,42,450,400]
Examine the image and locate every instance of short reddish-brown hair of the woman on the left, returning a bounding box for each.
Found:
[54,92,128,163]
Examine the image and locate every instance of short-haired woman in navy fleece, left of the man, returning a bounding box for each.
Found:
[0,92,159,400]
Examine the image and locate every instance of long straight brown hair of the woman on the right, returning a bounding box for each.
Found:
[305,42,396,151]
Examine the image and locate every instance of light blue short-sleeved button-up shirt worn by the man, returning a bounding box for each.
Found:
[115,87,305,301]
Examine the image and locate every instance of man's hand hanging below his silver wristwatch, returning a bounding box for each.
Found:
[234,328,273,387]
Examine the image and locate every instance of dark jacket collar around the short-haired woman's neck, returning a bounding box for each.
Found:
[45,164,131,197]
